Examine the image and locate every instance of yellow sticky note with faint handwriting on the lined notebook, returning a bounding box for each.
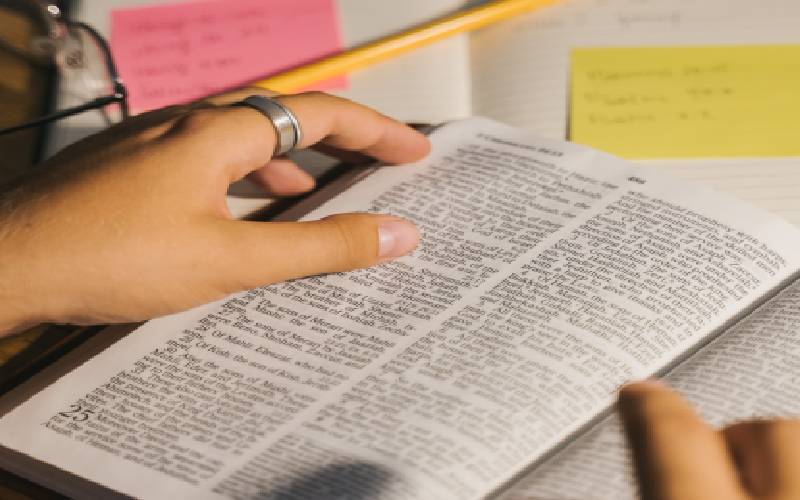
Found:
[570,45,800,158]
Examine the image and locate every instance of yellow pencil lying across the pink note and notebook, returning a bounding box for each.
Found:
[253,0,555,93]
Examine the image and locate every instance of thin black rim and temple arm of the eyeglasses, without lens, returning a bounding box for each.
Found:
[0,15,130,135]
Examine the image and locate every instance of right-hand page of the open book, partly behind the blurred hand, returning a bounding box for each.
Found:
[501,282,800,500]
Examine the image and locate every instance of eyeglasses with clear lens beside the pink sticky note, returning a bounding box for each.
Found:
[0,0,129,135]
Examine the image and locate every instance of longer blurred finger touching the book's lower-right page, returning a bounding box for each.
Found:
[618,381,747,500]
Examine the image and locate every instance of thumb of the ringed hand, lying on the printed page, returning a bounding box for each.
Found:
[212,214,419,292]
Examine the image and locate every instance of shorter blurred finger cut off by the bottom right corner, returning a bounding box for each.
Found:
[723,420,800,500]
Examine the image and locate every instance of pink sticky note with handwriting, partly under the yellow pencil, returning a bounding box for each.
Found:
[111,0,346,112]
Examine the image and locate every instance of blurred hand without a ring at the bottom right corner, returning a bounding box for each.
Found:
[619,381,800,500]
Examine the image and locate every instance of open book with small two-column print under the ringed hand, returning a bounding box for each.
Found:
[0,119,800,500]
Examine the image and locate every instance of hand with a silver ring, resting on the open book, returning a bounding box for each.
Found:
[0,90,429,333]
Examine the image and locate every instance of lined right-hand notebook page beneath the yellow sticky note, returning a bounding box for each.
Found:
[471,0,800,225]
